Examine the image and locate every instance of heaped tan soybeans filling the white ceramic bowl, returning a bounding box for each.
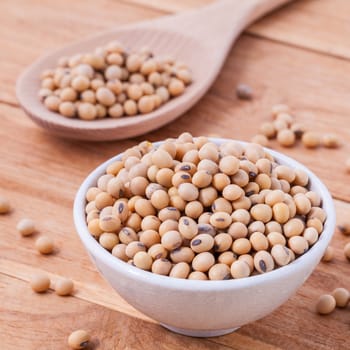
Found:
[86,133,326,280]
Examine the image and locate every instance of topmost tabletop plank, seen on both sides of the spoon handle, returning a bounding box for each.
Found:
[122,0,350,59]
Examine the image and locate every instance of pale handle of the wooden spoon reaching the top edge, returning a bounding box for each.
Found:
[146,0,291,53]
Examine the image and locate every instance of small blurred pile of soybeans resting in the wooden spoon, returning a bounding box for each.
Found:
[39,41,192,120]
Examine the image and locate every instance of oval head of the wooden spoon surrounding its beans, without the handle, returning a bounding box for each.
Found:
[17,28,211,141]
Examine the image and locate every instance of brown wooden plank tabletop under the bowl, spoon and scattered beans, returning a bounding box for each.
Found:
[0,0,350,350]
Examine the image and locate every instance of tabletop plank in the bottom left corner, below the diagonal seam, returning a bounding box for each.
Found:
[0,273,239,350]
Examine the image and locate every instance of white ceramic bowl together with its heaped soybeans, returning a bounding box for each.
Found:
[74,133,335,336]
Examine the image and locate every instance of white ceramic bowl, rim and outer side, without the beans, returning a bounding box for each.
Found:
[74,139,335,337]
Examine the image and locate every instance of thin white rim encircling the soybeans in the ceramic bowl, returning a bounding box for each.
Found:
[73,137,336,291]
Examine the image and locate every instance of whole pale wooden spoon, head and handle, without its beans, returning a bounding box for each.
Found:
[16,0,290,141]
